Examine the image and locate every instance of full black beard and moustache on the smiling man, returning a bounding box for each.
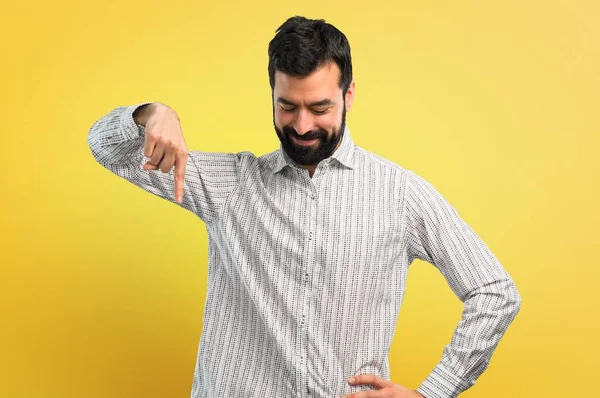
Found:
[273,101,346,166]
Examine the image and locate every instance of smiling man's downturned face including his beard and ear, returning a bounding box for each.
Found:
[273,62,354,166]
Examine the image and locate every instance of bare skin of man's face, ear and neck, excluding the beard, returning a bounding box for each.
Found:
[273,62,355,177]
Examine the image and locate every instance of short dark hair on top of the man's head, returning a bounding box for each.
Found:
[269,15,352,95]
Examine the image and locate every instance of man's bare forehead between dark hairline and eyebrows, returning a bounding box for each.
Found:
[273,62,342,101]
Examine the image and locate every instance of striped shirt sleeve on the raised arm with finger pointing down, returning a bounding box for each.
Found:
[87,102,241,223]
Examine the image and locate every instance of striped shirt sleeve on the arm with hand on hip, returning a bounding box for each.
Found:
[405,171,521,398]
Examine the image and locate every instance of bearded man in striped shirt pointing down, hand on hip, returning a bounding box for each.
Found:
[88,16,521,398]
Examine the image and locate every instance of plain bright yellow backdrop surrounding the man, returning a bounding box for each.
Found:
[0,0,600,398]
